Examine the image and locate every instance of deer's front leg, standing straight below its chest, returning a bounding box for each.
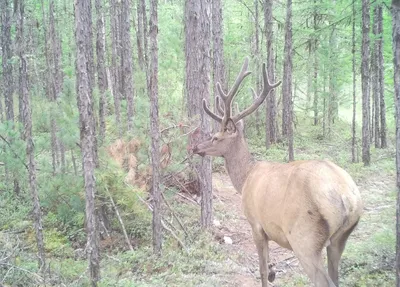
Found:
[252,225,275,287]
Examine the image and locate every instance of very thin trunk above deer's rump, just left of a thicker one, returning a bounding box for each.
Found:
[351,2,357,163]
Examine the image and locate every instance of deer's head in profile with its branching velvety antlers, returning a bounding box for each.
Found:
[193,58,281,157]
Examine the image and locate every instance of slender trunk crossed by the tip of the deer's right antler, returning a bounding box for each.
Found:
[264,0,277,147]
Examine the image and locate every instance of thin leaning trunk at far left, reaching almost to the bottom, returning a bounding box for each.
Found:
[14,0,46,272]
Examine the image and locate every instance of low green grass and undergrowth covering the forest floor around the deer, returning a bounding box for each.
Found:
[0,115,396,287]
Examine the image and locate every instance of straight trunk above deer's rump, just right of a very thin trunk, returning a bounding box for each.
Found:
[361,0,370,165]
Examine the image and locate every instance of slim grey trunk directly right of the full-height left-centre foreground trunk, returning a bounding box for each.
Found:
[95,0,108,141]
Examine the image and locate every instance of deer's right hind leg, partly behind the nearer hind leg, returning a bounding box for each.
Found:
[326,222,358,287]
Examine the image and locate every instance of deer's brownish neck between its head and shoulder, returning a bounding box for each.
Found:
[224,138,255,193]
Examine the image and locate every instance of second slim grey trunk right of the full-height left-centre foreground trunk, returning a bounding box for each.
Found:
[110,0,122,138]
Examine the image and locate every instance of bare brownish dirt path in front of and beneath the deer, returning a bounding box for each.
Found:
[213,173,301,287]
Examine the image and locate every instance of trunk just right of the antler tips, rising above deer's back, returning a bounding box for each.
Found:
[282,0,294,161]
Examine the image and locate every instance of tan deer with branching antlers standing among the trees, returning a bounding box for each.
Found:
[193,58,363,287]
